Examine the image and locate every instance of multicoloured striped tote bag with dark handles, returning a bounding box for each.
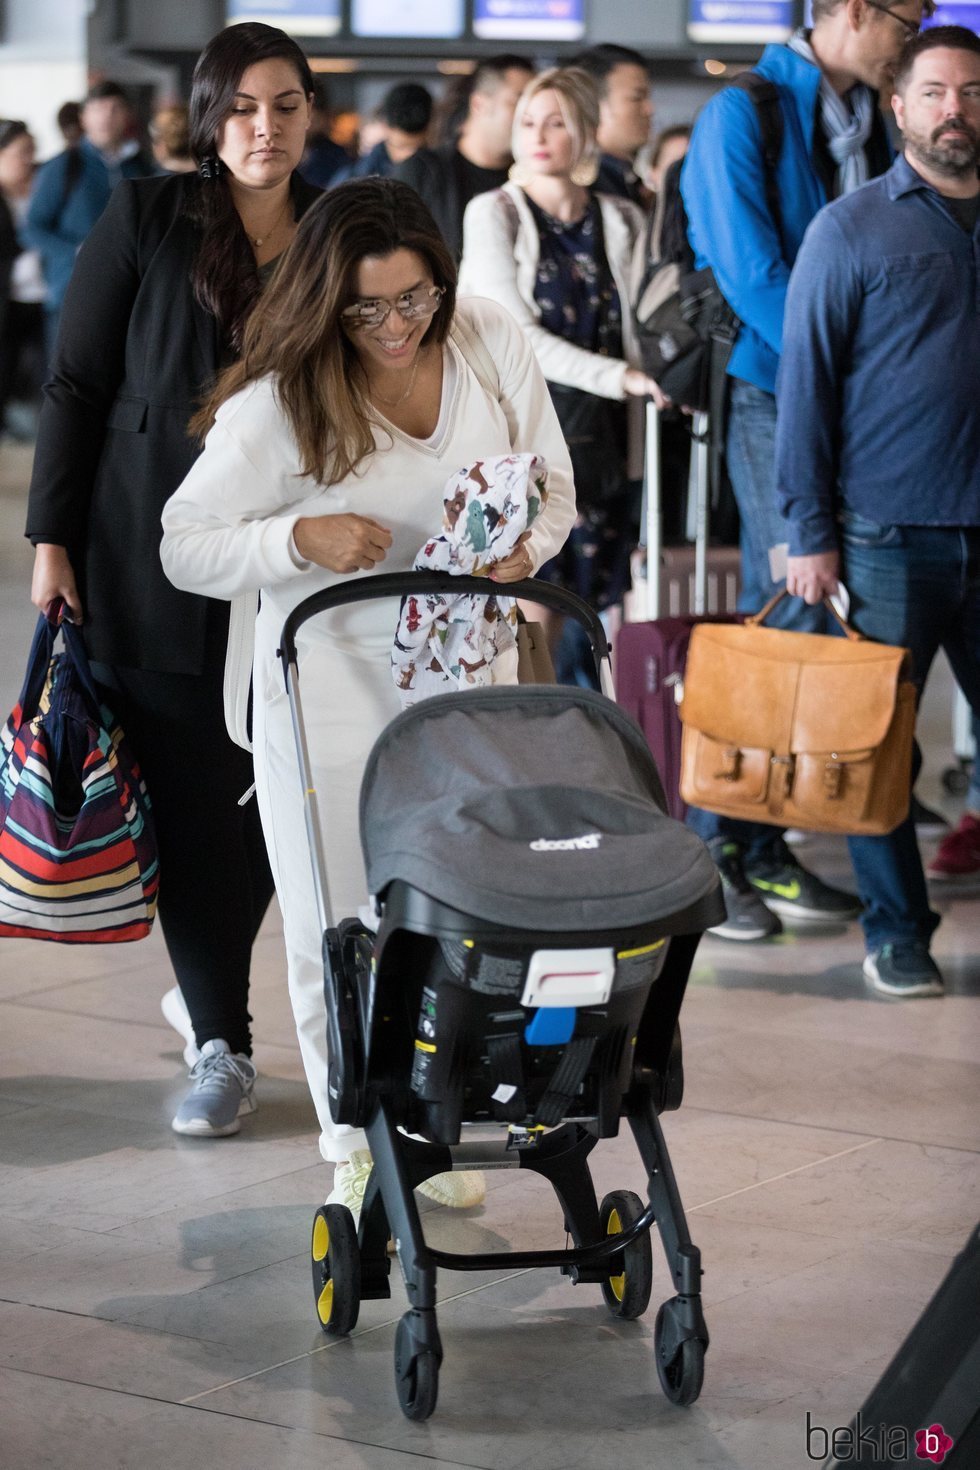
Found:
[0,604,159,944]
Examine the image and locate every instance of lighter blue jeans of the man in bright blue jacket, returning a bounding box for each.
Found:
[688,378,829,867]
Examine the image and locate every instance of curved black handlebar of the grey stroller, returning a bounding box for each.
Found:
[279,572,611,670]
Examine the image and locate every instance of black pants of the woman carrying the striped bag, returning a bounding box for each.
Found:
[93,617,273,1054]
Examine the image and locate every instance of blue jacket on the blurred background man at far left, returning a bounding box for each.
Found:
[24,138,159,312]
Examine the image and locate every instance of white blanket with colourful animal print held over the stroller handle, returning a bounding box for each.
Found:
[391,454,548,707]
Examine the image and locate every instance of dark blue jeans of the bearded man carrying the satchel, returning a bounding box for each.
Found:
[840,512,980,950]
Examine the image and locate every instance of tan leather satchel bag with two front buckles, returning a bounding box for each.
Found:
[680,592,915,836]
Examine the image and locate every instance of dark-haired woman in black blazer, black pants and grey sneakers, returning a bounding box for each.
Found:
[26,24,320,1136]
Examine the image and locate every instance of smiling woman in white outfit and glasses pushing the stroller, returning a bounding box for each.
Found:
[162,178,574,1213]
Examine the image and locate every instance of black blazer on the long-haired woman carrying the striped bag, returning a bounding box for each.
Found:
[26,173,322,673]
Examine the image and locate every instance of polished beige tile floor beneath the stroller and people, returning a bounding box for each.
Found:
[0,444,980,1470]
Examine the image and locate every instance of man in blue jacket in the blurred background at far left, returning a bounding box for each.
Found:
[24,81,157,357]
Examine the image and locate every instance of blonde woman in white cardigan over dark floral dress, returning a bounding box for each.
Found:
[460,68,664,645]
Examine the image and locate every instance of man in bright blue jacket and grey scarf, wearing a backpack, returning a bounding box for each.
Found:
[680,0,932,939]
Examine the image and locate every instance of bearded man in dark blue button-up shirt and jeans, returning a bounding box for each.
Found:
[776,26,980,995]
